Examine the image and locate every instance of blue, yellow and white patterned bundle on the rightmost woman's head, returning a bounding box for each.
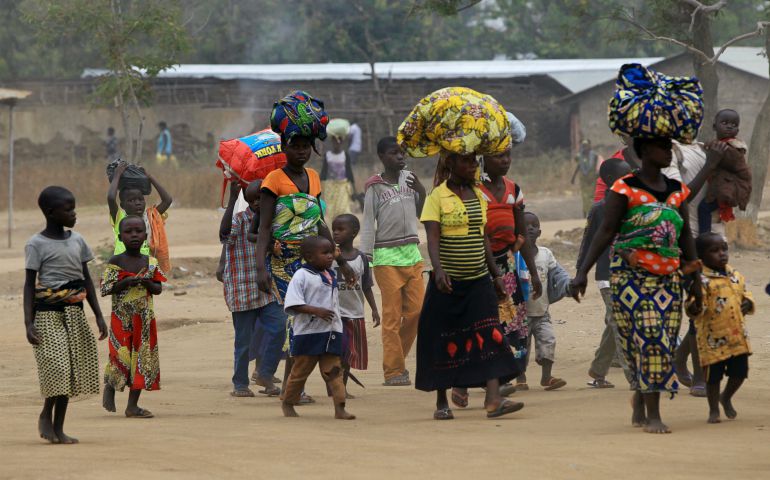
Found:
[609,63,703,144]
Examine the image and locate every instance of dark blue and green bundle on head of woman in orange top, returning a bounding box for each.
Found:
[270,90,329,142]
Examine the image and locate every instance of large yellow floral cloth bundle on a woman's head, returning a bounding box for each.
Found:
[396,87,511,158]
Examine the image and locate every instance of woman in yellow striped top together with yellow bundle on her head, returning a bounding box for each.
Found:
[398,87,524,420]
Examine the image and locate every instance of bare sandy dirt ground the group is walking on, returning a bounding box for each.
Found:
[0,202,770,479]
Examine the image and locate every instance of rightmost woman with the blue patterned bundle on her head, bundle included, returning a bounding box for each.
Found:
[571,64,703,433]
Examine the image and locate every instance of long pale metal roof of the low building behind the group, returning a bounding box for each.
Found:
[83,57,662,92]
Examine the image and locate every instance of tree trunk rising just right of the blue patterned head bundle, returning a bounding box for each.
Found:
[690,7,719,135]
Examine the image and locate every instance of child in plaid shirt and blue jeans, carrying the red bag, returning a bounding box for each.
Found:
[219,180,286,397]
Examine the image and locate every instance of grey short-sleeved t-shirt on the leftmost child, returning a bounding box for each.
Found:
[24,230,94,288]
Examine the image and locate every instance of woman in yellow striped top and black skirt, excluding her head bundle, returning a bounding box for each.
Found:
[415,152,524,420]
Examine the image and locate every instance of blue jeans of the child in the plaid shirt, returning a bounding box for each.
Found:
[232,302,287,390]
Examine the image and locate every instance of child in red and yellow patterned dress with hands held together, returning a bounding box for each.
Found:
[101,215,166,418]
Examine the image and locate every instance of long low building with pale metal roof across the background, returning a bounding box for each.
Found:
[0,51,768,163]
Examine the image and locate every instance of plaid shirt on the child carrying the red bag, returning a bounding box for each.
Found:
[222,208,276,312]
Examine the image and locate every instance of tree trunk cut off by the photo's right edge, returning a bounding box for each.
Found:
[745,29,770,224]
